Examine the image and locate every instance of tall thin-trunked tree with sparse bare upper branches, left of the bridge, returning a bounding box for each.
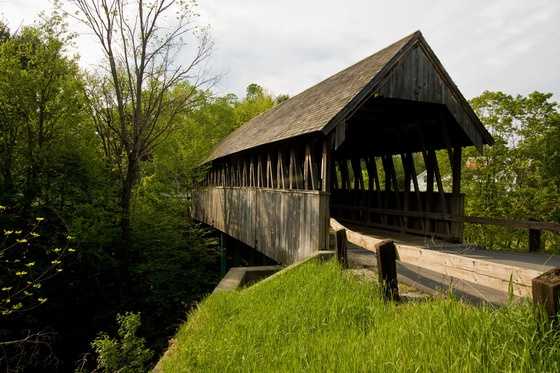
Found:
[73,0,212,281]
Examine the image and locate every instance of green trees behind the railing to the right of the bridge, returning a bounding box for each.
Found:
[463,92,560,250]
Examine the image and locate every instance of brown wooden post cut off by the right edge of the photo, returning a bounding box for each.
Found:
[531,268,560,320]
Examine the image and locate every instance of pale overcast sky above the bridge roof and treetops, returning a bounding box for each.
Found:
[0,0,560,100]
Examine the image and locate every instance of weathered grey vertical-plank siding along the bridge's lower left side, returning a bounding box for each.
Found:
[192,187,329,264]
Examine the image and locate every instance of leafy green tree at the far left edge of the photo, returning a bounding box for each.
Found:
[0,12,83,206]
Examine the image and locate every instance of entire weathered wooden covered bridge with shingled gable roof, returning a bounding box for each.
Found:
[192,31,493,264]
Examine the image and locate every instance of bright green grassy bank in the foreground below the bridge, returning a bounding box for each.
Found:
[161,262,560,372]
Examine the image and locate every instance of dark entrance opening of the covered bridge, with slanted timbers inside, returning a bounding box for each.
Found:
[330,98,470,241]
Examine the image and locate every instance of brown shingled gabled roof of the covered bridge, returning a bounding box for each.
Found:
[204,31,492,163]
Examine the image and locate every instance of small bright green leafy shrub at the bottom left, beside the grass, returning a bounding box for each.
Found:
[91,312,153,373]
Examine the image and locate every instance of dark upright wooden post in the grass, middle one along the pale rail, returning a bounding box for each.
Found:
[375,240,400,301]
